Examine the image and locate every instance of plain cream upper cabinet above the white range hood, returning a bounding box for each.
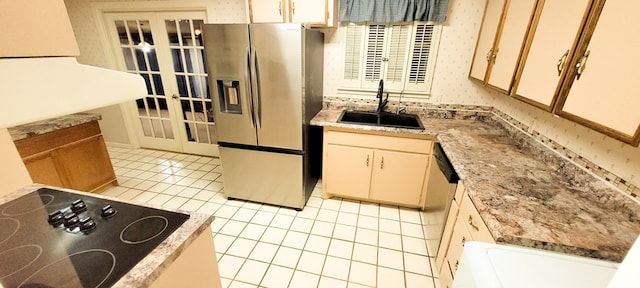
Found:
[0,0,80,58]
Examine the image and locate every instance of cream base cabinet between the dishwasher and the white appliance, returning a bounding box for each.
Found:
[436,181,495,287]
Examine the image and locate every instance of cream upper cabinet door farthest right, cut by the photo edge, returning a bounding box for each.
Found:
[558,0,640,145]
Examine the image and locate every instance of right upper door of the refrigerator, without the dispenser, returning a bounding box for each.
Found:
[249,24,303,150]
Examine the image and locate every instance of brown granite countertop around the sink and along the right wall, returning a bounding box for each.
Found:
[311,109,640,262]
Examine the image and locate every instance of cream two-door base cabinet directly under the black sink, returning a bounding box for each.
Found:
[322,127,433,207]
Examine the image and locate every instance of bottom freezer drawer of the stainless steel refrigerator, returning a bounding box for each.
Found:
[220,147,306,209]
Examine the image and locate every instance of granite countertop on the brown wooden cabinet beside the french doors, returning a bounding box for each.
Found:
[8,112,102,141]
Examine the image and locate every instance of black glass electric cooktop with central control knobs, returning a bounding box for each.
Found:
[0,188,189,288]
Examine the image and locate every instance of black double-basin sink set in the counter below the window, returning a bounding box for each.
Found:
[338,110,424,130]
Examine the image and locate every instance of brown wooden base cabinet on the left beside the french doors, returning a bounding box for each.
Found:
[14,121,117,192]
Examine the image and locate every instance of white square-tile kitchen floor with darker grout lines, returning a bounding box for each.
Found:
[103,147,439,288]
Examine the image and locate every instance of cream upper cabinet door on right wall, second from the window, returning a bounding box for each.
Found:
[487,0,537,93]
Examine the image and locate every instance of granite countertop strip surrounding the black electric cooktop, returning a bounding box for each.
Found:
[0,184,214,288]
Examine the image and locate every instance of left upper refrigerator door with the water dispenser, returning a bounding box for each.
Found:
[202,24,257,145]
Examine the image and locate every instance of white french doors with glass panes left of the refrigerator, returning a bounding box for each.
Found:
[105,12,218,156]
